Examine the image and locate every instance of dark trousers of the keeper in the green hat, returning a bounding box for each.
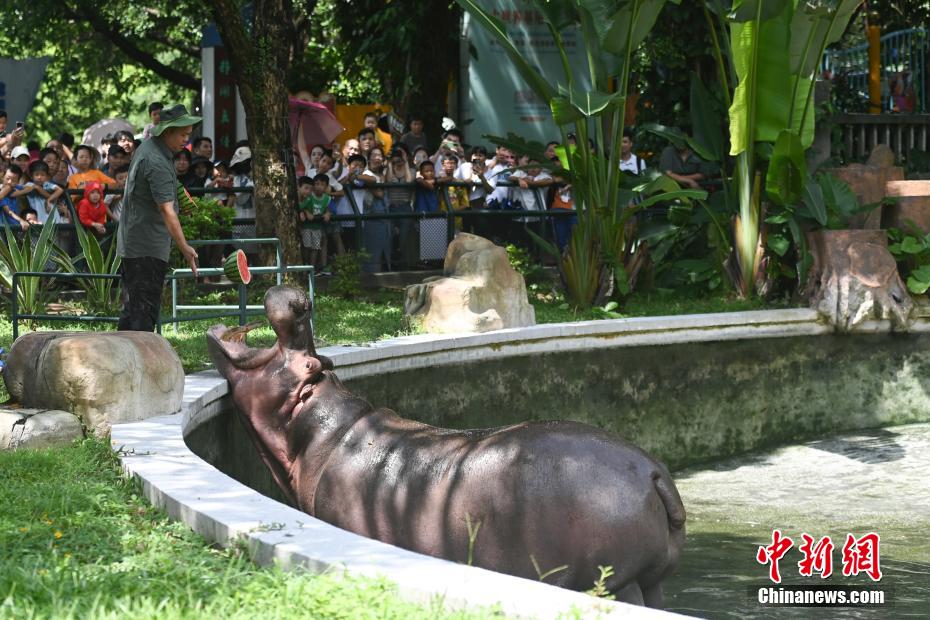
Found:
[117,256,168,332]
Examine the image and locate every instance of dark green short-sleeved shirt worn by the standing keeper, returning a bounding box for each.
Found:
[116,136,178,262]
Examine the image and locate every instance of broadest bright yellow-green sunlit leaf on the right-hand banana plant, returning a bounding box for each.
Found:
[730,4,793,156]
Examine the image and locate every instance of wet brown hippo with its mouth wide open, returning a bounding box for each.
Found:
[207,286,685,607]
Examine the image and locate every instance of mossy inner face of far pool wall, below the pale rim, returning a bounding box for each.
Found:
[344,334,930,469]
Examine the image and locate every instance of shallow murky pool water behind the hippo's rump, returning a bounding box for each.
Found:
[665,424,930,618]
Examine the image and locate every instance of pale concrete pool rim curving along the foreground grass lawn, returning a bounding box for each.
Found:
[111,371,683,619]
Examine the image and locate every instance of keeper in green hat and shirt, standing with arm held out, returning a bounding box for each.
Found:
[116,104,200,332]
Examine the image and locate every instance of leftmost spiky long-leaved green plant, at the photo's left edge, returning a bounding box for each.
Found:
[0,218,63,314]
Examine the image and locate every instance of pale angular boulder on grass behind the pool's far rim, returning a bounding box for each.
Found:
[404,233,536,333]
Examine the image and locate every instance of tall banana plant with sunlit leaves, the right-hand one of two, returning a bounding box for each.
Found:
[705,0,862,296]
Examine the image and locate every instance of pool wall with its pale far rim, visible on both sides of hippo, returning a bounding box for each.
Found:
[185,310,930,474]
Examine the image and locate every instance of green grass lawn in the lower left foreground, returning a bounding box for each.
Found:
[0,439,498,619]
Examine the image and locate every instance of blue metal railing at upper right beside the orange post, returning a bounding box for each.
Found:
[822,28,928,112]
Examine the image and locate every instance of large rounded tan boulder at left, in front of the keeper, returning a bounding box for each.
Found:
[3,332,184,436]
